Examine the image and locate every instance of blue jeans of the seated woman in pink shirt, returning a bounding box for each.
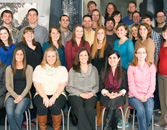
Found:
[128,97,154,130]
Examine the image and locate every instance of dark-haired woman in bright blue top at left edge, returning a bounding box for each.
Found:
[0,27,15,66]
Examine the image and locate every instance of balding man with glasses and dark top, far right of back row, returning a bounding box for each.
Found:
[154,11,166,34]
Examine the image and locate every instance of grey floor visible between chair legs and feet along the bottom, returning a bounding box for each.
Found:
[0,112,164,130]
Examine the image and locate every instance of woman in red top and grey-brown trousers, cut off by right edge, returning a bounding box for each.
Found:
[154,24,167,129]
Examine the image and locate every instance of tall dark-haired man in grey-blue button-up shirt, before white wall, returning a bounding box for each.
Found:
[18,8,48,46]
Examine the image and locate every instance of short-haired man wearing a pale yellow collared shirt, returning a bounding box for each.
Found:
[82,15,95,46]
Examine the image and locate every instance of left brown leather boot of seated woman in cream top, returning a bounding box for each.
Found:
[37,115,47,130]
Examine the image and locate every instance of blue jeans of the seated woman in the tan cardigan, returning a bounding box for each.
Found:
[5,97,30,130]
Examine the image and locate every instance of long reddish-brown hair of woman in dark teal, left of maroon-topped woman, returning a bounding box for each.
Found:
[49,25,63,49]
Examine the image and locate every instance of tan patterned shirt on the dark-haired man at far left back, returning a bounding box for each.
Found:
[0,24,19,44]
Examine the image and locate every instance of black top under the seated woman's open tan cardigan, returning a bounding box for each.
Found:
[13,69,29,97]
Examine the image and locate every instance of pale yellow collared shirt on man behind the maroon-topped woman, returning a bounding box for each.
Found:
[84,29,95,46]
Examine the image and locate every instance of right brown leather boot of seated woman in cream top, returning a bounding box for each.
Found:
[52,114,62,130]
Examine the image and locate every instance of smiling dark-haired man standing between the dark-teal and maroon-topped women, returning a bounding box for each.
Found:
[59,15,72,47]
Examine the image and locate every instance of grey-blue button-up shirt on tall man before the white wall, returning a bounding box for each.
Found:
[17,24,49,46]
